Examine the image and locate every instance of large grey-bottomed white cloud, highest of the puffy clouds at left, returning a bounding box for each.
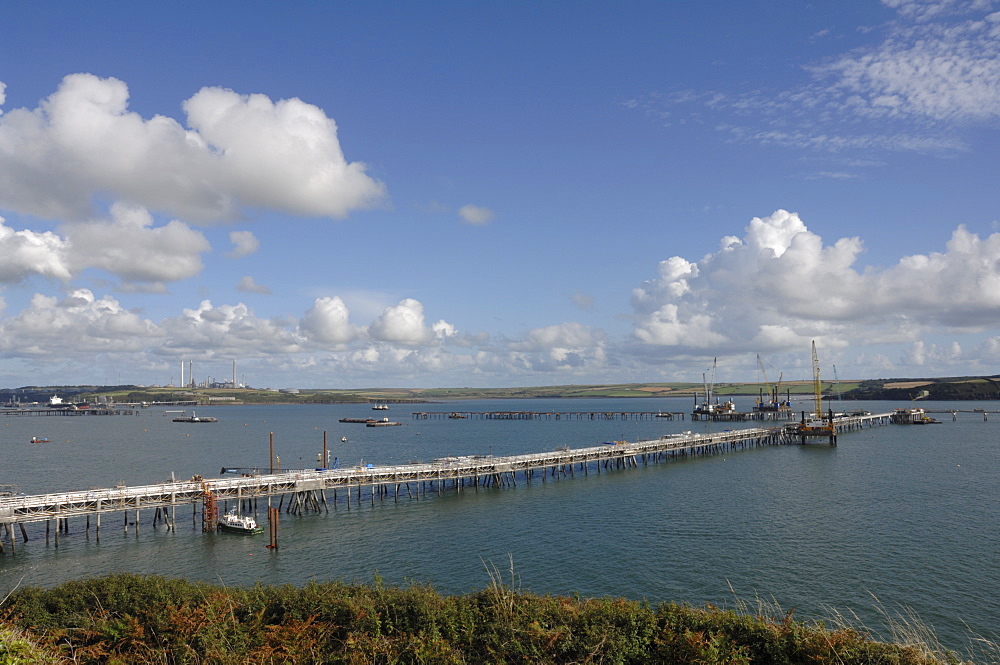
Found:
[0,74,385,222]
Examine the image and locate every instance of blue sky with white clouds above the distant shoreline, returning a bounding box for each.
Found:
[0,0,1000,388]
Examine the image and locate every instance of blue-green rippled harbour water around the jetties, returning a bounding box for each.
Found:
[0,398,1000,653]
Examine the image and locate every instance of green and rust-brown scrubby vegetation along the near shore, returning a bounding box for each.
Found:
[0,574,961,665]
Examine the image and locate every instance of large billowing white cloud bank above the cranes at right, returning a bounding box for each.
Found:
[632,210,1000,357]
